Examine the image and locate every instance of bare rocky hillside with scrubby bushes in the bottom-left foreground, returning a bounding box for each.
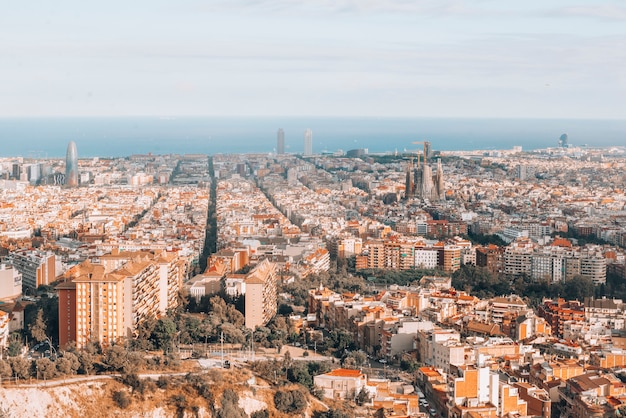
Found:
[0,369,346,418]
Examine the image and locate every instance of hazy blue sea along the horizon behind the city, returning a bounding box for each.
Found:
[0,117,626,158]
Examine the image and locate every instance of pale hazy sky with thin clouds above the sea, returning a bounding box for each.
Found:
[0,0,626,119]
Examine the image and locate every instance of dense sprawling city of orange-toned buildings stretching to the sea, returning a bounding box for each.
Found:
[0,134,626,418]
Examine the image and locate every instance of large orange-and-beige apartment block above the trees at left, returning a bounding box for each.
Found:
[56,252,185,348]
